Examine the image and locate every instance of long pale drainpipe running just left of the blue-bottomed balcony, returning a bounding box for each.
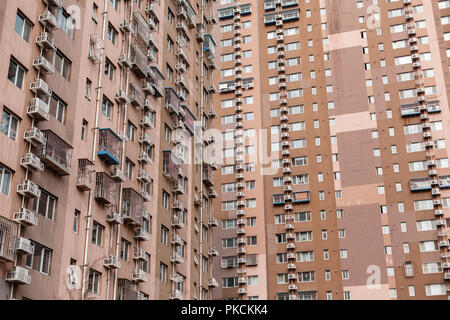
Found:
[81,0,108,300]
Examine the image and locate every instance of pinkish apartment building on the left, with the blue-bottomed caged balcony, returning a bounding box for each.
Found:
[0,0,217,300]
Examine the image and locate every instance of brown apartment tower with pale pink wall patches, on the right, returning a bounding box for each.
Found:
[213,0,450,300]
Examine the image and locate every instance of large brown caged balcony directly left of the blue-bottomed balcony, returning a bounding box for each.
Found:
[39,130,73,176]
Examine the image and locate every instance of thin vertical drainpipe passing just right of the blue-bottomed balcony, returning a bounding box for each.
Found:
[113,2,133,300]
